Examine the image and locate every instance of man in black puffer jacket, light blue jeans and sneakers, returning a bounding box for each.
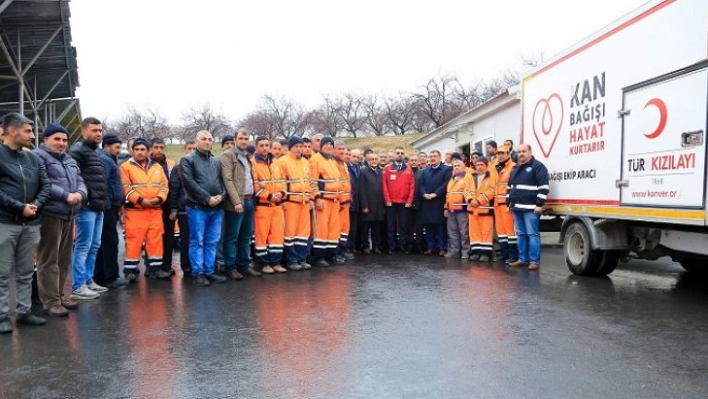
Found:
[69,118,108,300]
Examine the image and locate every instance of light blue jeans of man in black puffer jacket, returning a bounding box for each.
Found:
[71,209,103,290]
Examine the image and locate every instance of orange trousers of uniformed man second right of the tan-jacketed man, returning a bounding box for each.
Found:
[283,201,311,264]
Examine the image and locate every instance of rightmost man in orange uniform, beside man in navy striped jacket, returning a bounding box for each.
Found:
[494,146,519,264]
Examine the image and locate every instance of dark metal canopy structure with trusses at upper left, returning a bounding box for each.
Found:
[0,0,81,141]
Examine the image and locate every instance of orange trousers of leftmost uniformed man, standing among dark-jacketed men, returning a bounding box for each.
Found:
[124,208,165,273]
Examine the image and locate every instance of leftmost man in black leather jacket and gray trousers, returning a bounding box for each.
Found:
[0,113,51,333]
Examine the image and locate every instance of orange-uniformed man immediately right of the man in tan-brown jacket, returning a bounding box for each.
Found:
[252,136,287,274]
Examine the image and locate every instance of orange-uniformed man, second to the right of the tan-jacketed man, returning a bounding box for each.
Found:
[277,136,312,270]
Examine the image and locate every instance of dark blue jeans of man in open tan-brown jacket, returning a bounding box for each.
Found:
[224,199,254,273]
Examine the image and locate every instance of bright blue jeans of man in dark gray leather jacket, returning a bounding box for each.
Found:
[187,206,224,277]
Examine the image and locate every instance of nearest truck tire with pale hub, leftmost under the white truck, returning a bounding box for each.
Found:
[563,222,602,276]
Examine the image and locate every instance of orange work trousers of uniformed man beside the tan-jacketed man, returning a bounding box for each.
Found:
[254,205,285,266]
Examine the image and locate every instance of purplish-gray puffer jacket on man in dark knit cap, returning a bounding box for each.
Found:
[32,144,88,220]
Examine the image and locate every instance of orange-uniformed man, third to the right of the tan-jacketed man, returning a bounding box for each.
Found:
[310,136,344,267]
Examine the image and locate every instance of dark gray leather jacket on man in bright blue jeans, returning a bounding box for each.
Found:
[180,150,226,209]
